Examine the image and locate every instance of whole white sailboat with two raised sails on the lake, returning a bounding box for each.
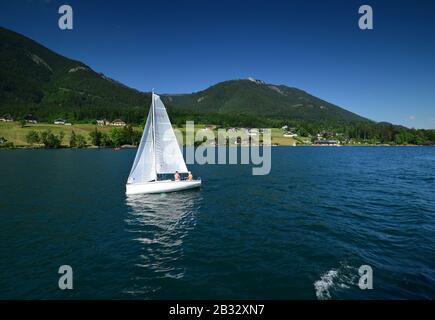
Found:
[126,92,201,195]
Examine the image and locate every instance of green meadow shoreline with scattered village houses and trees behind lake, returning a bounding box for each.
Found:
[0,114,432,148]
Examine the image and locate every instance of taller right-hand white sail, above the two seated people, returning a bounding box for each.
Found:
[153,93,188,174]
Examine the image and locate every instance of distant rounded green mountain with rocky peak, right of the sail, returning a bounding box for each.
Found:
[164,78,369,122]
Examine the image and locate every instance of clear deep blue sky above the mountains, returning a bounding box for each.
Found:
[0,0,435,128]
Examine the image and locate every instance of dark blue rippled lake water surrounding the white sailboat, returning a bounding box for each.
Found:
[0,147,435,299]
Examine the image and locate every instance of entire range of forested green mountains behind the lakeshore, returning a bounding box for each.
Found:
[0,27,367,123]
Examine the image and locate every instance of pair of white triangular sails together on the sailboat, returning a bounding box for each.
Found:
[127,93,187,183]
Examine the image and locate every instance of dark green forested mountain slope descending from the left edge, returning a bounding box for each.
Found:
[0,27,150,117]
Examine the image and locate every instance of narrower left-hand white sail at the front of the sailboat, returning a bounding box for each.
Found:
[127,106,157,183]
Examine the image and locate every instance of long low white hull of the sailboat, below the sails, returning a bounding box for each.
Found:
[125,180,201,195]
